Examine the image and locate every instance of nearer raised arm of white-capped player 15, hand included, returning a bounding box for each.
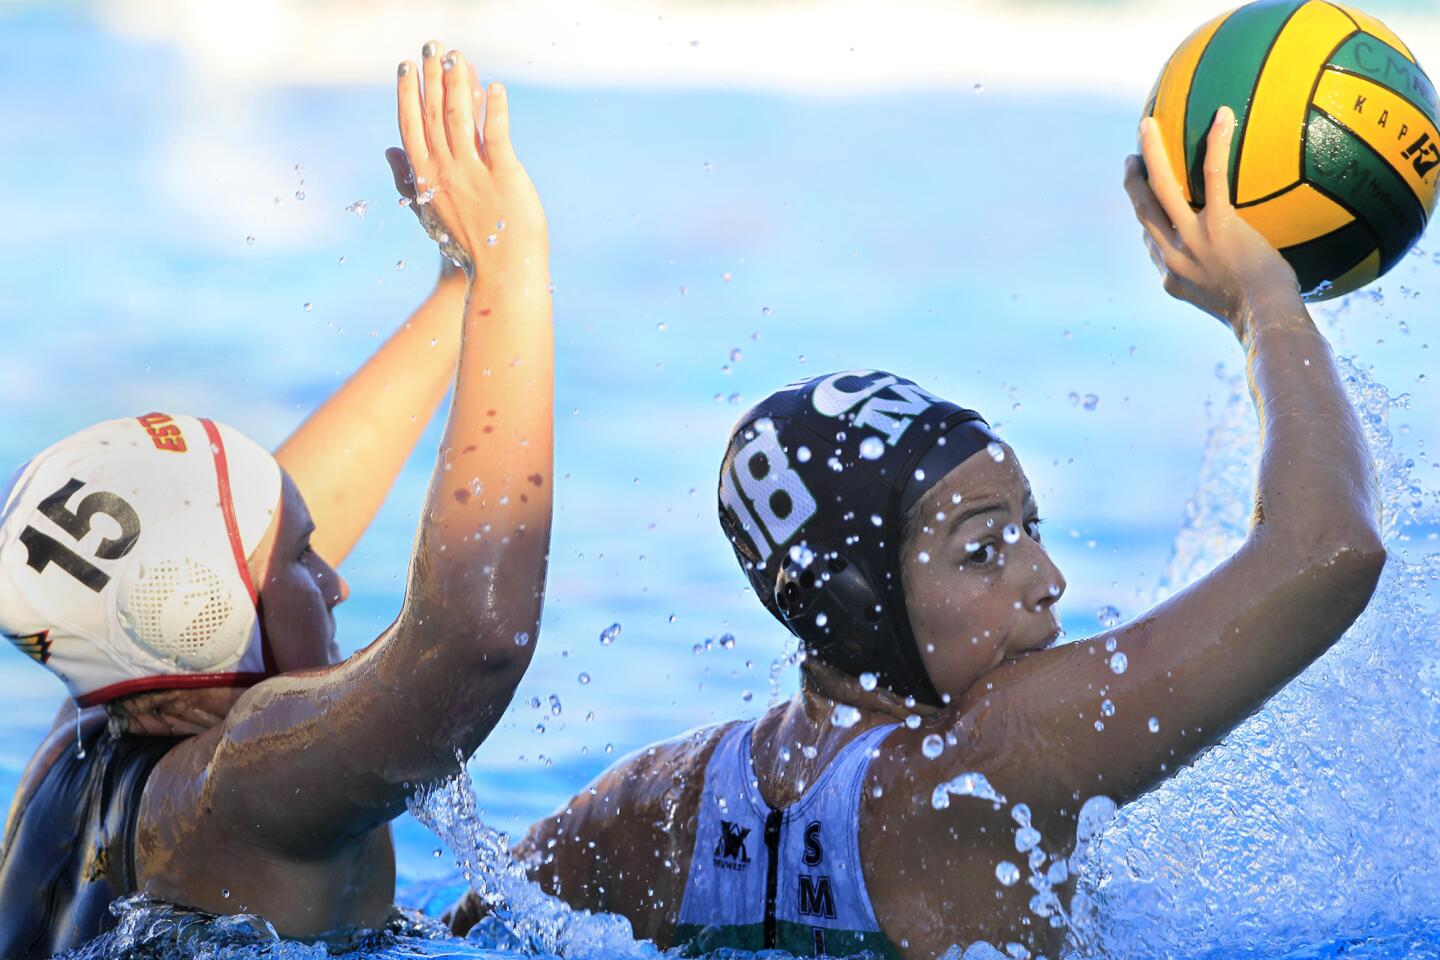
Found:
[147,45,553,863]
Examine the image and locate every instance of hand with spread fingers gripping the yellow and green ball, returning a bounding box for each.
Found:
[1125,107,1300,340]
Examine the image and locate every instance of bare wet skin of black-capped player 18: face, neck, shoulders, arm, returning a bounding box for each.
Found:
[469,111,1385,959]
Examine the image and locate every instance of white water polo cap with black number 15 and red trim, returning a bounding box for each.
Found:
[0,413,281,707]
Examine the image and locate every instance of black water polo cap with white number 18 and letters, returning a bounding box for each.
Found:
[720,370,999,705]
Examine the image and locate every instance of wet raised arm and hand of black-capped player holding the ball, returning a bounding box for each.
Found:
[921,109,1385,816]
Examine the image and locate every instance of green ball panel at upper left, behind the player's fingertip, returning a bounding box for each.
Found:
[1185,0,1309,206]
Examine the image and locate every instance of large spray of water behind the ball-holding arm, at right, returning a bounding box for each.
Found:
[1077,360,1440,957]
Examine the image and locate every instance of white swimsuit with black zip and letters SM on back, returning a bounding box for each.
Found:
[675,721,899,959]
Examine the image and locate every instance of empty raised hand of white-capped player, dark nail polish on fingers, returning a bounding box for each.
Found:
[386,40,549,273]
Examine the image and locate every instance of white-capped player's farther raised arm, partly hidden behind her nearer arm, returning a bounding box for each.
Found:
[275,259,467,566]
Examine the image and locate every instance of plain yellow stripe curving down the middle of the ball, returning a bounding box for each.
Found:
[1236,0,1355,204]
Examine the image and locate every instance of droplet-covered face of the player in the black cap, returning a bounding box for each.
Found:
[901,445,1066,698]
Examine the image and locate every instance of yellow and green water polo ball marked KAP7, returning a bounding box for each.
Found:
[1145,0,1440,299]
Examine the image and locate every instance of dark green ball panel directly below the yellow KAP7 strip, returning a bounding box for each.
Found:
[1305,109,1426,273]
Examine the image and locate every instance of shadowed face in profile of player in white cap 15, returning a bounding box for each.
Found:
[251,474,350,674]
